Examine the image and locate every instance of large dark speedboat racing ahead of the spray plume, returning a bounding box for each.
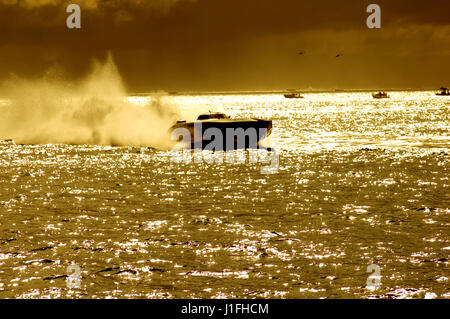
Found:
[169,113,272,150]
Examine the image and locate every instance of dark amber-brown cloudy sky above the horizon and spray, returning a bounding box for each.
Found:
[0,0,450,93]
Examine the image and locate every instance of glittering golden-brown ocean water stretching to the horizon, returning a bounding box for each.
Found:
[0,92,450,298]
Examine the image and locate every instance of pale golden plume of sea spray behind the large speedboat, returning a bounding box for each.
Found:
[0,57,178,149]
